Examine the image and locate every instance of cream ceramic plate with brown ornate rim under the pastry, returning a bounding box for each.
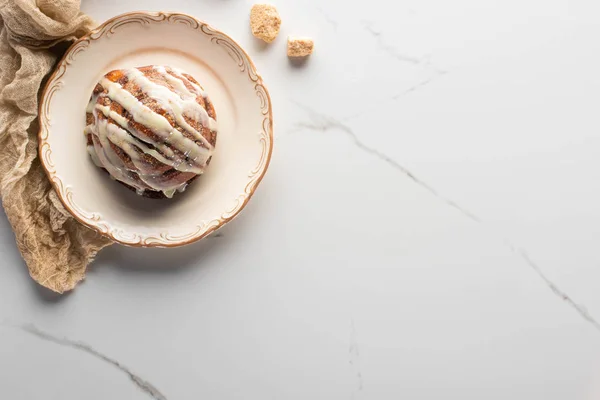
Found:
[39,12,273,247]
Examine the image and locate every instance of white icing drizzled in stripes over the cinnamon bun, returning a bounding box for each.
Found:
[84,67,217,198]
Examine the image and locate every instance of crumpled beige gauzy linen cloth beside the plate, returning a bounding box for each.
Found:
[0,0,111,293]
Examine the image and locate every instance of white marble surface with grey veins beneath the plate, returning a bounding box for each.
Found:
[0,0,600,400]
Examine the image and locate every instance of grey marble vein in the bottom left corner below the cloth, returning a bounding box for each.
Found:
[2,324,167,400]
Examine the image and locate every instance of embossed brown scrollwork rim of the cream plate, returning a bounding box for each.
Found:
[38,12,273,247]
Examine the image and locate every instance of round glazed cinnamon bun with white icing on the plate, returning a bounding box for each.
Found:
[85,66,217,198]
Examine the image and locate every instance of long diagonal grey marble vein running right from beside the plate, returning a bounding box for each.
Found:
[294,102,600,331]
